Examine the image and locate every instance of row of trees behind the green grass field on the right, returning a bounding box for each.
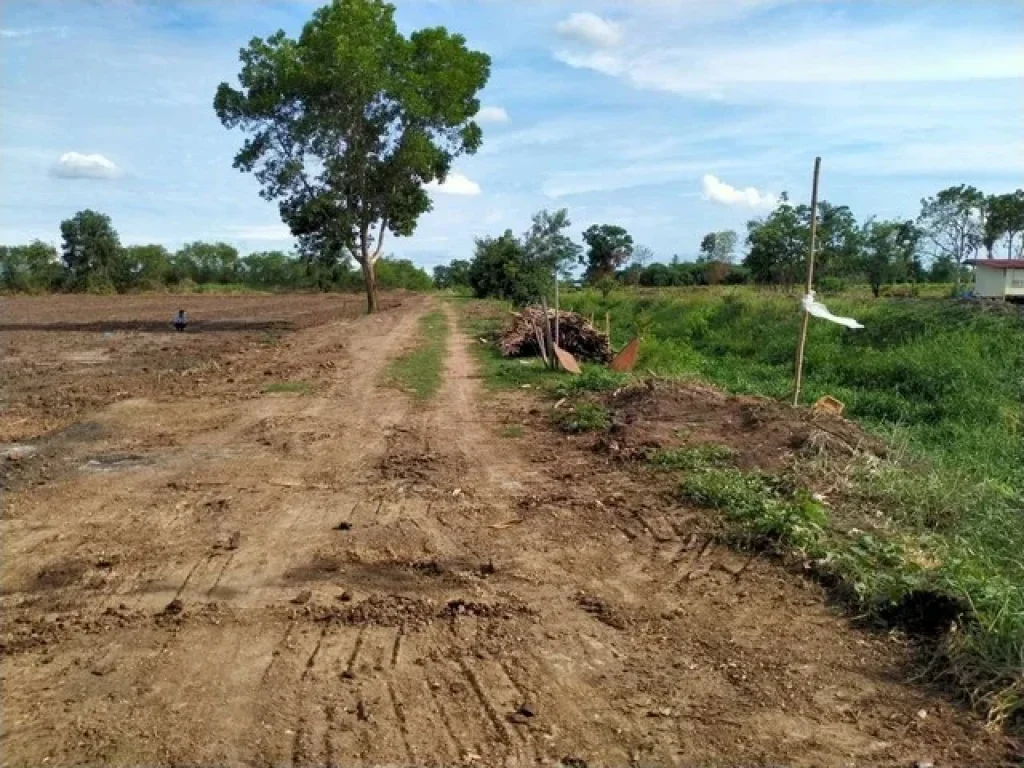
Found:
[434,184,1024,303]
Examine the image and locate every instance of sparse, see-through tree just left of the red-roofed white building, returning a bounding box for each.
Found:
[918,184,986,290]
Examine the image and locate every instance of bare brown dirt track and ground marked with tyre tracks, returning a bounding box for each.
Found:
[0,298,1007,766]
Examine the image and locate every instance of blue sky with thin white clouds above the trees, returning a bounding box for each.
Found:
[0,0,1024,267]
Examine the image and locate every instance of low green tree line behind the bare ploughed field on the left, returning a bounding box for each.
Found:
[0,210,433,293]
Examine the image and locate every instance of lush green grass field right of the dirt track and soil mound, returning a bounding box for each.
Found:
[563,288,1024,720]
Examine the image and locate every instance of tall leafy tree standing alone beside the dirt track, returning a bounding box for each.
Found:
[214,0,490,311]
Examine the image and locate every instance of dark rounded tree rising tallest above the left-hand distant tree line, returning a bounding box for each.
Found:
[60,209,121,291]
